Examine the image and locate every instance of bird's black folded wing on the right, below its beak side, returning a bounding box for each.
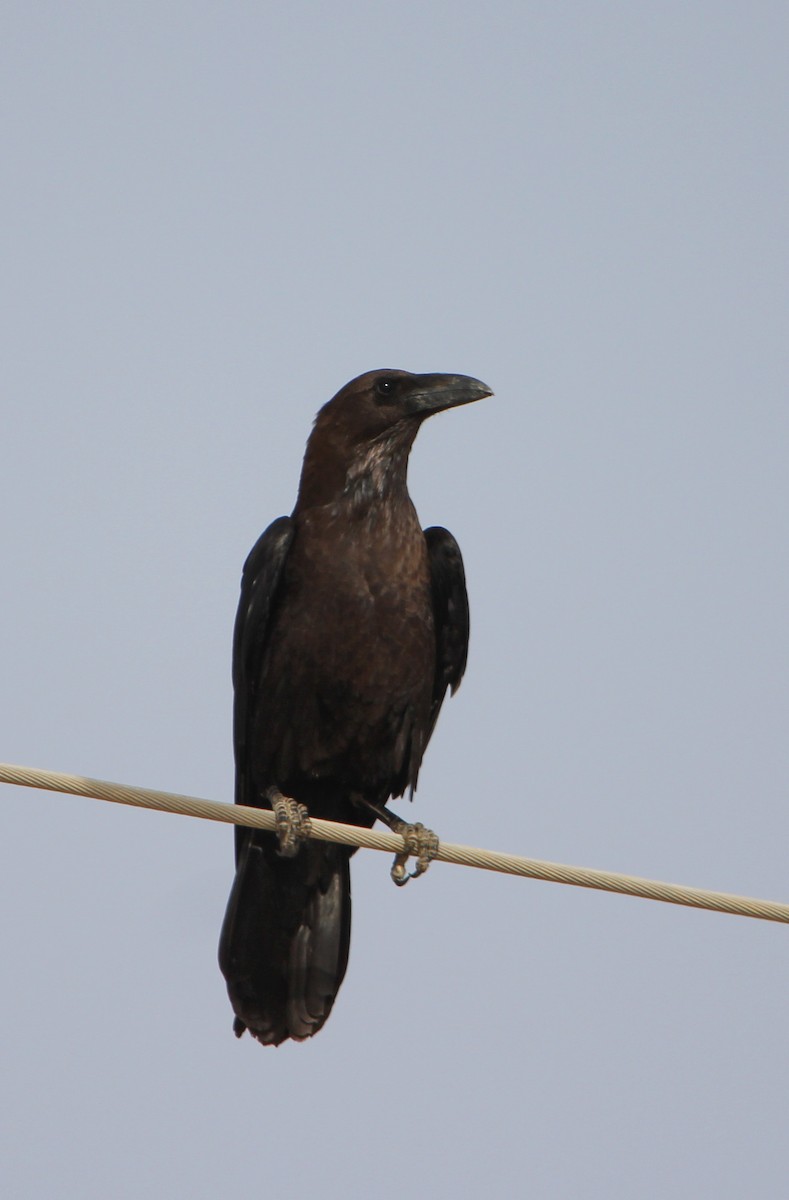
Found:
[424,526,469,743]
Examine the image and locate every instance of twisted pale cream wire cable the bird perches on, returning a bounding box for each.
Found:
[0,763,789,924]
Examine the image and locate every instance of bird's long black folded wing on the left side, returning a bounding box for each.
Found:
[233,517,295,804]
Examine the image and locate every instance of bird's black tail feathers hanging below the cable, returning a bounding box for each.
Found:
[219,830,350,1045]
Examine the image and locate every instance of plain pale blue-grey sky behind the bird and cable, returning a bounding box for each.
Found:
[0,0,789,1200]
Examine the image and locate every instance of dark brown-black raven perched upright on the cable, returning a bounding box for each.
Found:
[219,371,492,1045]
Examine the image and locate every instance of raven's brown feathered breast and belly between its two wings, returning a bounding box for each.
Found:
[265,504,435,786]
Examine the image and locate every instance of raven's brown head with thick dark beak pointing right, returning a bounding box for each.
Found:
[300,371,493,505]
